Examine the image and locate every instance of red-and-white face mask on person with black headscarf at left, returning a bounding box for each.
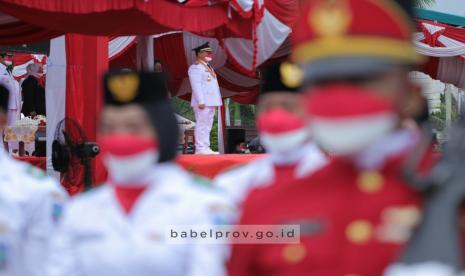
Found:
[99,134,159,185]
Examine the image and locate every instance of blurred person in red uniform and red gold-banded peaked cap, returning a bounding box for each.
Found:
[230,0,438,276]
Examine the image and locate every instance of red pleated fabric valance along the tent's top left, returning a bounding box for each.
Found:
[0,0,258,45]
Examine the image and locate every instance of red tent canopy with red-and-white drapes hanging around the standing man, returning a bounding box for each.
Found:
[0,0,301,102]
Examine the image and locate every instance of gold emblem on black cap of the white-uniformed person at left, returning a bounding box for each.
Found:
[108,74,140,103]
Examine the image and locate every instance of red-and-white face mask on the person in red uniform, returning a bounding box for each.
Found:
[307,84,398,155]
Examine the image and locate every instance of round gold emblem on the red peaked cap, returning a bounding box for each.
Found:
[308,0,352,37]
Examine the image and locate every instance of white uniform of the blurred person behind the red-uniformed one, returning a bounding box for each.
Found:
[213,143,328,210]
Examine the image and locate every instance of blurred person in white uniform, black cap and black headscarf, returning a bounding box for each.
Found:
[48,71,228,276]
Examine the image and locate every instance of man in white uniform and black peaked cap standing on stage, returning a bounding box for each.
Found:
[188,42,223,154]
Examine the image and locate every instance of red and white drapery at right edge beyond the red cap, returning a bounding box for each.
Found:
[414,20,465,89]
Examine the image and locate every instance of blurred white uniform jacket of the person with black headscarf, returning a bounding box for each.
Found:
[48,163,226,276]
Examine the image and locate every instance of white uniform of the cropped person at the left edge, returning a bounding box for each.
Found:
[0,149,67,276]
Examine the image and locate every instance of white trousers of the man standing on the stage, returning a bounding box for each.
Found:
[192,106,217,151]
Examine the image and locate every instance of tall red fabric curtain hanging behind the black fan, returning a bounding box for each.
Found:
[66,34,108,194]
